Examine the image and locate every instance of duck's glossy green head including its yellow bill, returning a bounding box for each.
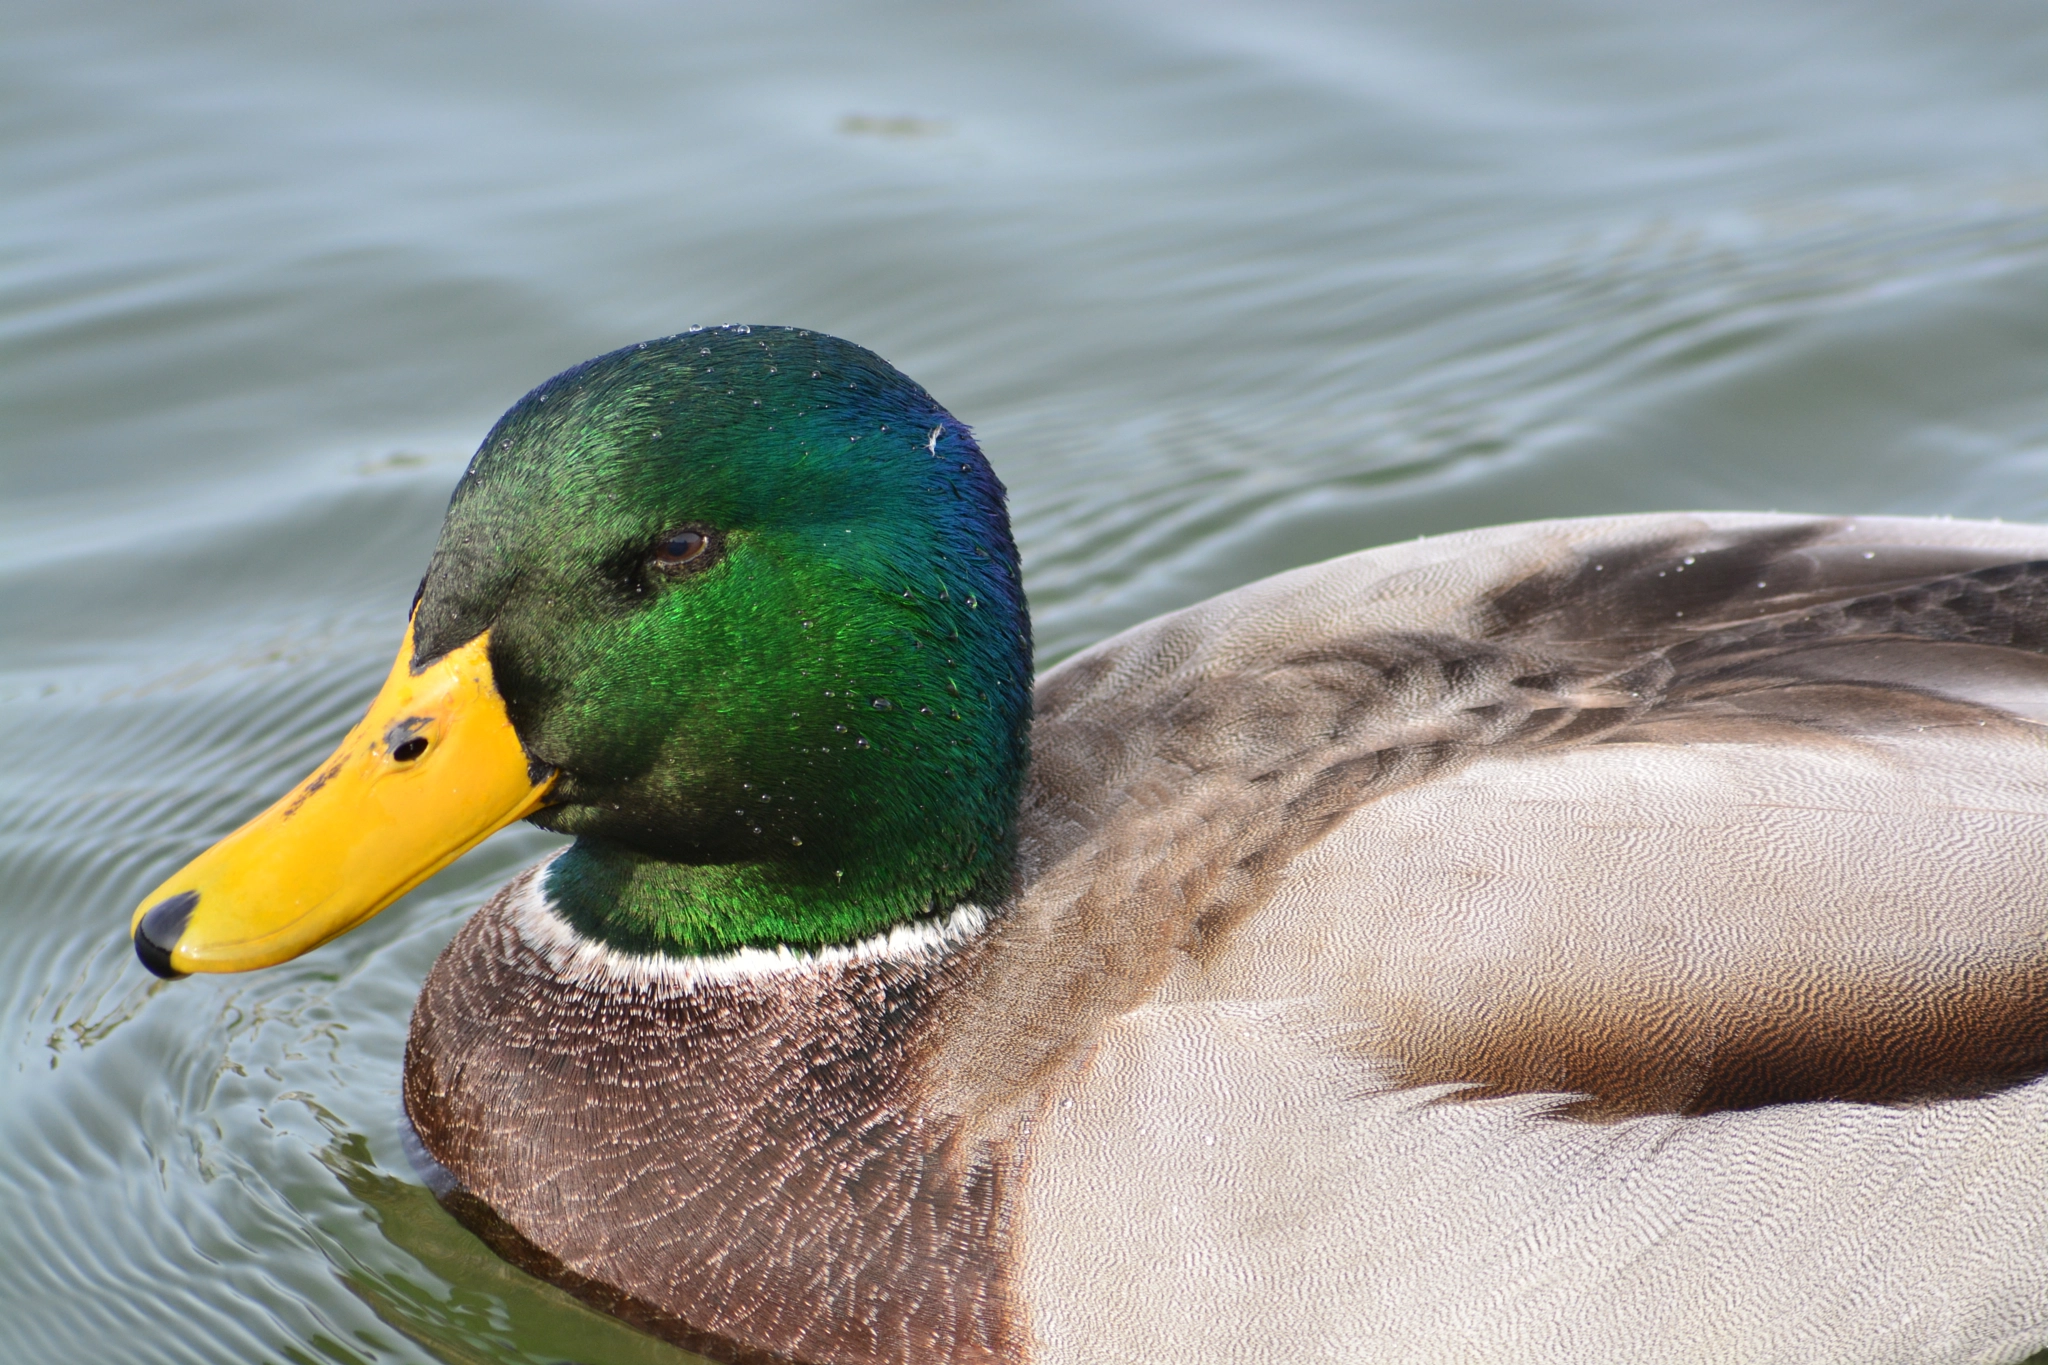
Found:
[131,327,1030,976]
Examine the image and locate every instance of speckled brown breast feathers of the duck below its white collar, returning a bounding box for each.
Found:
[406,888,1018,1361]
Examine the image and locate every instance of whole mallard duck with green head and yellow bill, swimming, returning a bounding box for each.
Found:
[131,325,2048,1365]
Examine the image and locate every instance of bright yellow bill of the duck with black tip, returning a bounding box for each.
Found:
[129,628,555,976]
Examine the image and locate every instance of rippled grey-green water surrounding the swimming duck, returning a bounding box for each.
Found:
[0,0,2048,1365]
